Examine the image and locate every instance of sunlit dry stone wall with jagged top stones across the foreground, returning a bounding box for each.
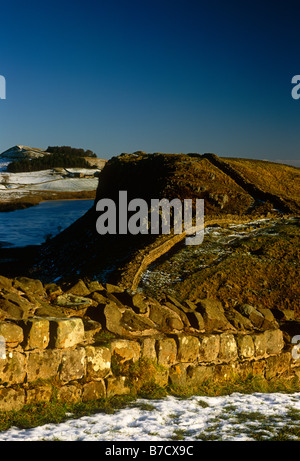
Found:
[0,277,300,411]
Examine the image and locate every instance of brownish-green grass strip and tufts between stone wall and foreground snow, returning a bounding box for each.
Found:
[0,372,300,434]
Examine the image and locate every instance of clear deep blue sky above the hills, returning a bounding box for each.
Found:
[0,0,300,165]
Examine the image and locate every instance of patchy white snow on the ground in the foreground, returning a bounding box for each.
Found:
[0,393,300,442]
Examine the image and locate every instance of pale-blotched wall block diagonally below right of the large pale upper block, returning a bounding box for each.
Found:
[85,346,111,380]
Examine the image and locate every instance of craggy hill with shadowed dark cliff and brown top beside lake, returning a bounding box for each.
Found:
[31,153,300,288]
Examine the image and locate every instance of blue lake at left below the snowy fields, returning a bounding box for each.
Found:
[0,200,93,248]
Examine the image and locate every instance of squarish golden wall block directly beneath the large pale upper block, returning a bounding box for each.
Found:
[59,347,86,383]
